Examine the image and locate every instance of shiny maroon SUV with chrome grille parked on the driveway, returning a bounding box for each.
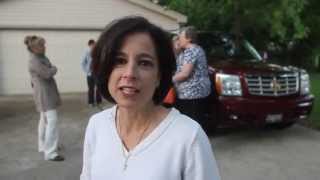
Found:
[199,33,314,128]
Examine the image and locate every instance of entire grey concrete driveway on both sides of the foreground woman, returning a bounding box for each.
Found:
[0,94,320,180]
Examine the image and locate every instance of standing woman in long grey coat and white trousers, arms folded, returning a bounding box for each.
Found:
[24,36,64,161]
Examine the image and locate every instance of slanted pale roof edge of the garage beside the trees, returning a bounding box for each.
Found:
[127,0,188,23]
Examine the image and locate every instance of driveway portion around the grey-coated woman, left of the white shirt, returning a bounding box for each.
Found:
[0,94,109,180]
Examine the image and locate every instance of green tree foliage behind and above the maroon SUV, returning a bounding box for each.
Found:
[160,0,320,69]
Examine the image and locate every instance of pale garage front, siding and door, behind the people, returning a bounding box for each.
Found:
[0,0,179,95]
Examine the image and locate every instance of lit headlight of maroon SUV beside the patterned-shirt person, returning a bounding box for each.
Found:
[216,73,242,96]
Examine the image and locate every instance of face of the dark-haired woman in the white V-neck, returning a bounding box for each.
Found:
[108,33,160,108]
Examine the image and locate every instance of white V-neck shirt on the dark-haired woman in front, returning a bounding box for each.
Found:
[80,106,220,180]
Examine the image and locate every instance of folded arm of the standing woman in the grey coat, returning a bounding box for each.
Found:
[29,59,57,79]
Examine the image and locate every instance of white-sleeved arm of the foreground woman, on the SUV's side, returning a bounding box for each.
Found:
[183,127,221,180]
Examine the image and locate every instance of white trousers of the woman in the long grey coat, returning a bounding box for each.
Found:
[38,109,59,160]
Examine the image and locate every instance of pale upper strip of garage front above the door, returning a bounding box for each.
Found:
[0,0,178,30]
